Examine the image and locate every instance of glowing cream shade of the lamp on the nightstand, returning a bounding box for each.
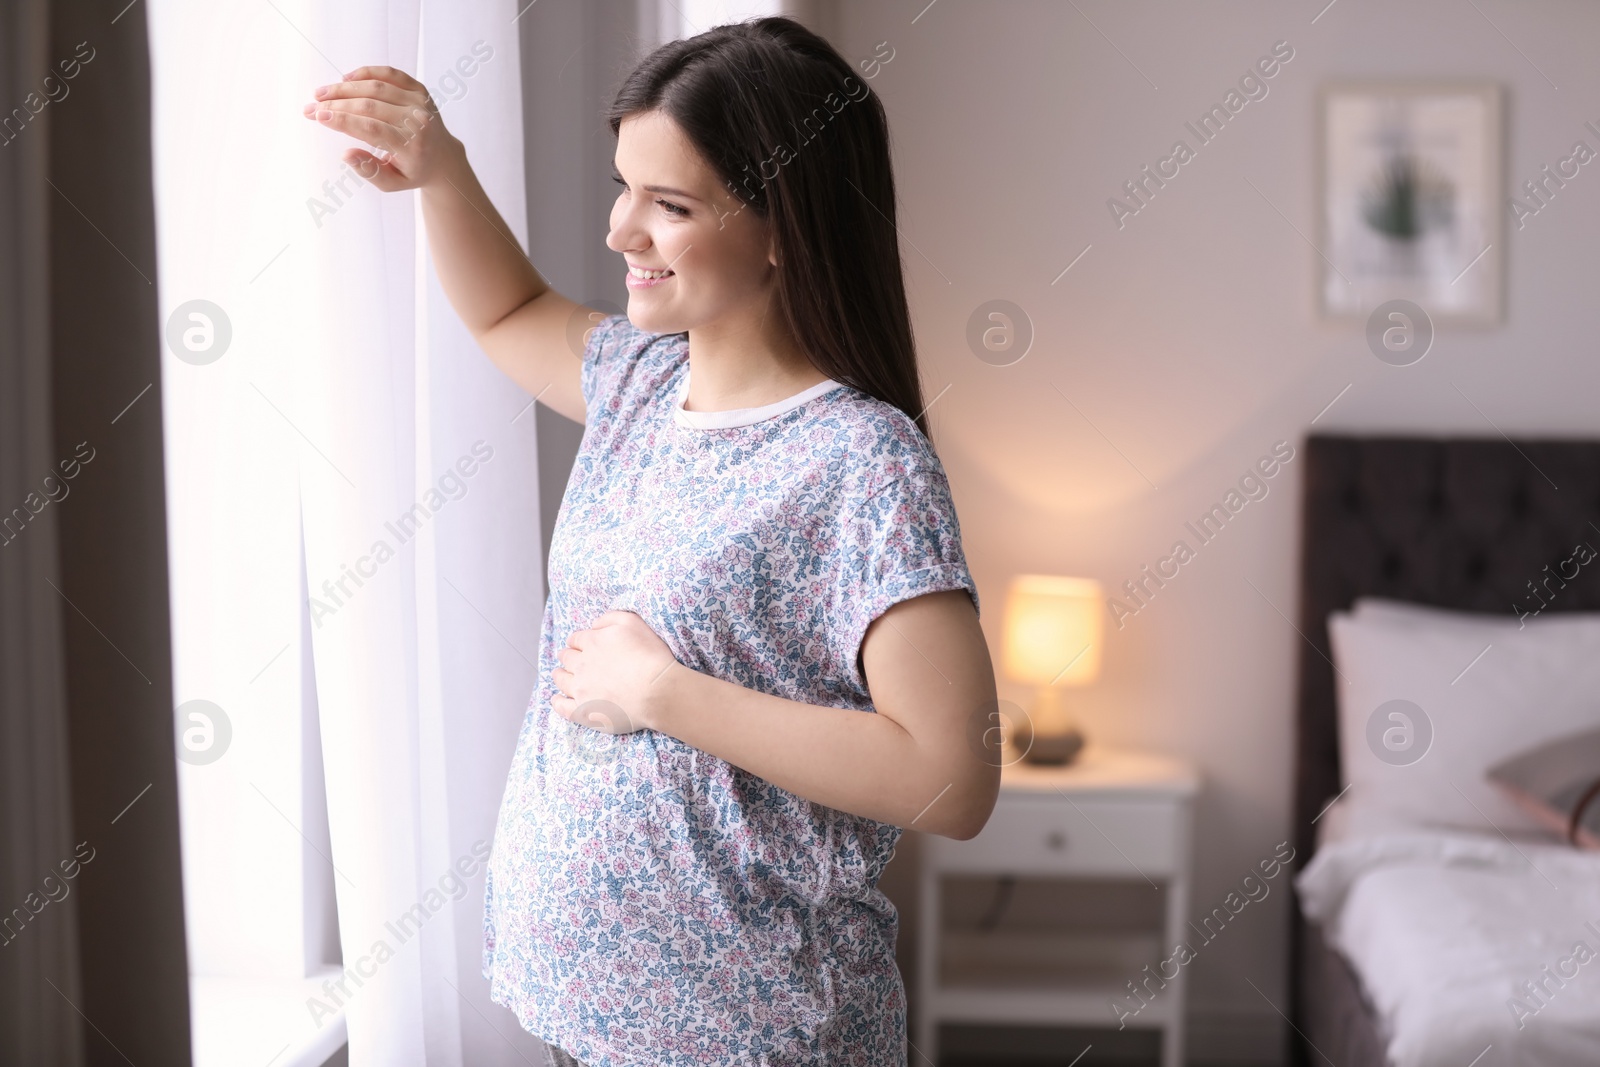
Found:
[1003,574,1106,686]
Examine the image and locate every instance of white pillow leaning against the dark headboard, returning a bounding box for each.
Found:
[1328,601,1600,832]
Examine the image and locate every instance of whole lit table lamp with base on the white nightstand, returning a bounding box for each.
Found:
[1003,574,1106,765]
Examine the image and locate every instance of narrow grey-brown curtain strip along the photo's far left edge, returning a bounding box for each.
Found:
[0,0,83,1067]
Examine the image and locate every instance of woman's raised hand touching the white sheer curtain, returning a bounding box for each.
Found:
[304,66,461,192]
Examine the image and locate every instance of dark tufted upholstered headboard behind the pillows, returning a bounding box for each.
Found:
[1294,435,1600,864]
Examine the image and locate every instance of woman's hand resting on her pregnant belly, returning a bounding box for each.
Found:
[550,611,680,734]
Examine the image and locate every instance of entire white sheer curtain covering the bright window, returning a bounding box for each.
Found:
[150,0,544,1065]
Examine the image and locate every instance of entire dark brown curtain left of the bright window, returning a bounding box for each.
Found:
[0,0,190,1067]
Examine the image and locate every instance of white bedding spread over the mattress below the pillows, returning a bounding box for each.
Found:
[1296,803,1600,1067]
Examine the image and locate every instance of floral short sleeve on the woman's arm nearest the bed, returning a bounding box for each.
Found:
[830,461,981,691]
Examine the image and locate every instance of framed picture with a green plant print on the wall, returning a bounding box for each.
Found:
[1317,82,1506,326]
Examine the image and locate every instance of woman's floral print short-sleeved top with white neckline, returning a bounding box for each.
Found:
[483,315,978,1067]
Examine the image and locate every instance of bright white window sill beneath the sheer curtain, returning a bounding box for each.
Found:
[189,966,346,1067]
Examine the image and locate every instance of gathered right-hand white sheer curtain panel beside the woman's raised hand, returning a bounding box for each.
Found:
[293,0,544,1065]
